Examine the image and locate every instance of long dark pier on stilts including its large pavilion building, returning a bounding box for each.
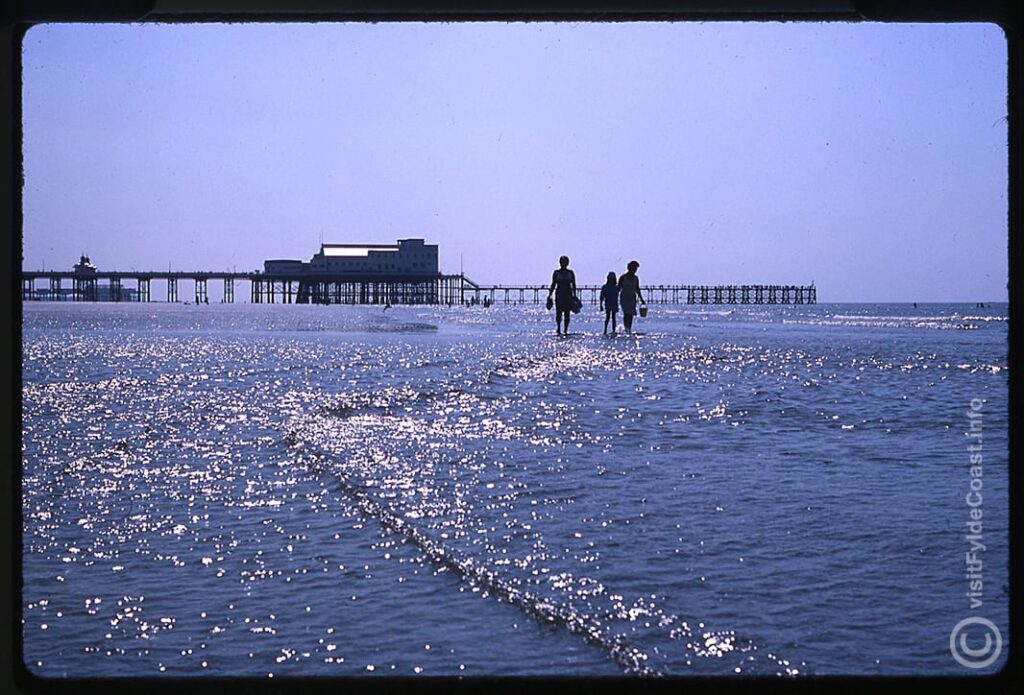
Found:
[22,247,817,306]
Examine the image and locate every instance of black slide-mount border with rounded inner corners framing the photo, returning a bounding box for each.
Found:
[0,0,1024,694]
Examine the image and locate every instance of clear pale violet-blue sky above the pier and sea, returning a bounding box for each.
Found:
[22,23,1009,302]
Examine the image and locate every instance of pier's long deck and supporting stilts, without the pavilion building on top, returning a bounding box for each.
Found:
[22,270,817,305]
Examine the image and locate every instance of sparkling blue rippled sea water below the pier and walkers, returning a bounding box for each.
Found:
[20,303,1009,678]
